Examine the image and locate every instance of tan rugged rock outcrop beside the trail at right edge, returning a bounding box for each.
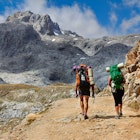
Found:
[125,41,140,109]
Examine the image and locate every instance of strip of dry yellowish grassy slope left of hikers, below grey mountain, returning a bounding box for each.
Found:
[0,83,74,103]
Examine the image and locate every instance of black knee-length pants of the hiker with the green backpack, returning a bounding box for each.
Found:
[112,89,124,106]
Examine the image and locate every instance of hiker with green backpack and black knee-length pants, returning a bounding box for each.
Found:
[108,65,125,119]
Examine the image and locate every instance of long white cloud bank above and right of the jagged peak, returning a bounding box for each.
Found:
[0,0,108,38]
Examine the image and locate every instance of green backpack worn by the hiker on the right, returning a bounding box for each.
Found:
[110,65,123,89]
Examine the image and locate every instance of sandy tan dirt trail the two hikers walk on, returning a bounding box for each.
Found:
[3,96,140,140]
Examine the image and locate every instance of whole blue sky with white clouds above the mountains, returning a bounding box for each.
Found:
[0,0,140,38]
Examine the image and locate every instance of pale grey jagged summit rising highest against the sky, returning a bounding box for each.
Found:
[6,11,62,35]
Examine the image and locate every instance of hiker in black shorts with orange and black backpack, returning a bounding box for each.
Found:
[75,64,94,119]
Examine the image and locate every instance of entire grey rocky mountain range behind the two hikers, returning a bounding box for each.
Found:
[0,11,140,88]
